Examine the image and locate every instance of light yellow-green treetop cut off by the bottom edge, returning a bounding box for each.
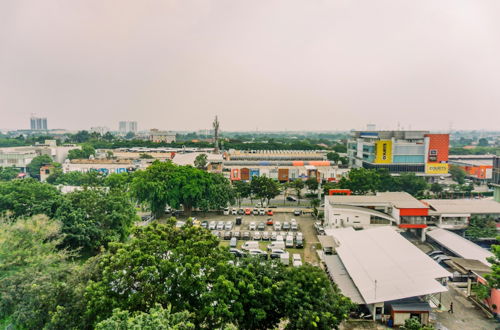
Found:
[95,304,194,330]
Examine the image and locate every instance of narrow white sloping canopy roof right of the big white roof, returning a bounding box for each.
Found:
[427,228,493,266]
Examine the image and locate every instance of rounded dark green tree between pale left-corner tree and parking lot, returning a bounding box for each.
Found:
[55,189,137,255]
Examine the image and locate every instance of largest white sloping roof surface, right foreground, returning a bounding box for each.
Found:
[329,227,451,304]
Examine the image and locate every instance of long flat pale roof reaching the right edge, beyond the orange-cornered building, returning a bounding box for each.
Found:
[424,199,500,215]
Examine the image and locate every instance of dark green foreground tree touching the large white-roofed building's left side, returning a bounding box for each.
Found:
[279,265,354,329]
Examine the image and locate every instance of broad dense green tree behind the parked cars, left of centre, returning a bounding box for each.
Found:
[132,161,234,217]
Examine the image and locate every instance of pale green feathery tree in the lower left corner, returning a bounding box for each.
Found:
[0,216,77,329]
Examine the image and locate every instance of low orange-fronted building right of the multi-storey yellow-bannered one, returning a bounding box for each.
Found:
[449,155,495,182]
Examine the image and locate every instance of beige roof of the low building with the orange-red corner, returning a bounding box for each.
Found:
[325,192,428,209]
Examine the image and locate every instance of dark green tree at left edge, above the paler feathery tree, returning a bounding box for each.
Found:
[0,179,62,217]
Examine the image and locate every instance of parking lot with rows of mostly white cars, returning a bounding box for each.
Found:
[170,209,319,265]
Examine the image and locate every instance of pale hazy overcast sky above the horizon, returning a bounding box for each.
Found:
[0,0,500,131]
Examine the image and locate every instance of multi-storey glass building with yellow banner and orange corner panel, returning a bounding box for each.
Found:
[347,131,450,176]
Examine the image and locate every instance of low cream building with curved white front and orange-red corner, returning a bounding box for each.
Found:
[324,192,429,240]
